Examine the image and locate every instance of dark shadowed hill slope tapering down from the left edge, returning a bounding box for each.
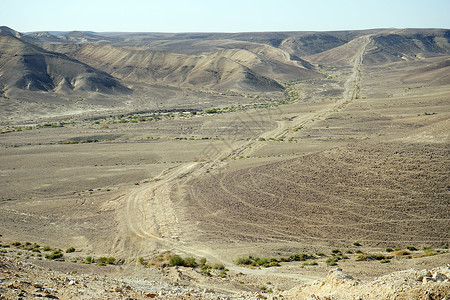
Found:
[0,35,129,93]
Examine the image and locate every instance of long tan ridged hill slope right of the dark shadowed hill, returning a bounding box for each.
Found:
[44,44,321,91]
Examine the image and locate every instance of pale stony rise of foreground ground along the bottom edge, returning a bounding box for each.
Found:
[0,256,450,299]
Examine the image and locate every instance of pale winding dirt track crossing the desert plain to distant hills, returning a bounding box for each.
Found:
[111,36,370,268]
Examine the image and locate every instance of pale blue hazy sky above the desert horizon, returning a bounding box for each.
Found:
[0,0,450,32]
